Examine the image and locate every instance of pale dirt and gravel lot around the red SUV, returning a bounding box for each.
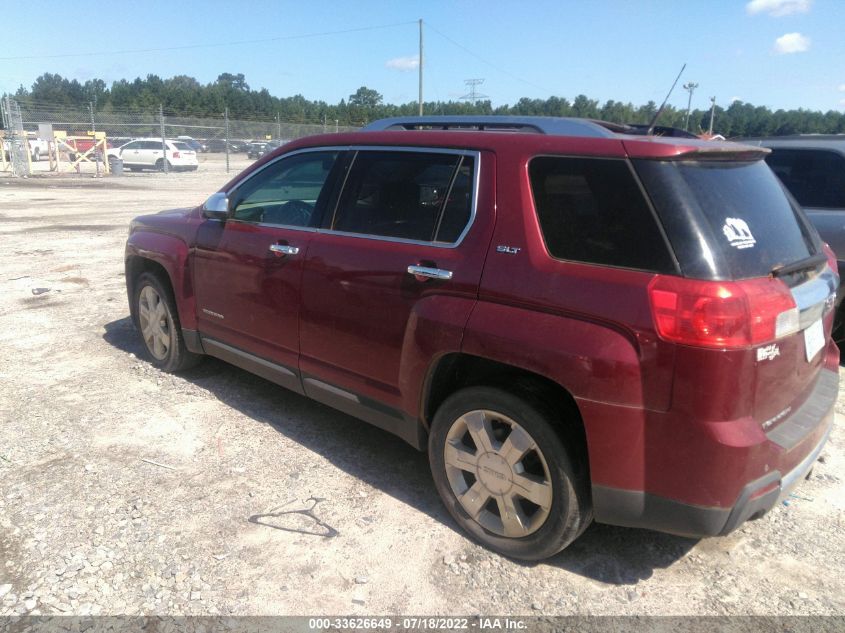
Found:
[0,155,845,615]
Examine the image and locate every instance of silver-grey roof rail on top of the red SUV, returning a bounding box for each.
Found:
[364,115,614,138]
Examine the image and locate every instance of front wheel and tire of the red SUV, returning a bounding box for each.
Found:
[134,272,202,372]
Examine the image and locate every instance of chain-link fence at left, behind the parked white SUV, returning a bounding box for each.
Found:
[2,97,359,174]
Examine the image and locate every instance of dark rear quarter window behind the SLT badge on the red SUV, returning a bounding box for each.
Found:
[528,157,675,272]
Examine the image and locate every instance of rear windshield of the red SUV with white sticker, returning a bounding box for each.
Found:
[634,160,818,279]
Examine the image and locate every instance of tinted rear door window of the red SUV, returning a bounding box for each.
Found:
[332,151,471,241]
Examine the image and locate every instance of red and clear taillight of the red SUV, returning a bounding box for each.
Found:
[648,275,799,349]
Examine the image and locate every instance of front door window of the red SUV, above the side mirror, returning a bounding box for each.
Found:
[231,152,337,226]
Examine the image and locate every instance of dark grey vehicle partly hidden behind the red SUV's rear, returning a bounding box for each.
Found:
[741,134,845,347]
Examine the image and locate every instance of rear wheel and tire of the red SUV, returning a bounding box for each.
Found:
[428,387,592,560]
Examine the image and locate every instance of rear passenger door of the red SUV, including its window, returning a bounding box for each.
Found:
[300,148,493,414]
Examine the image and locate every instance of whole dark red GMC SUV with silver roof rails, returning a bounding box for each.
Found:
[126,117,839,559]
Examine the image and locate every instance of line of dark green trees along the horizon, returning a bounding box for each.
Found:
[6,73,845,138]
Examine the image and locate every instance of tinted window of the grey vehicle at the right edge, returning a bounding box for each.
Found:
[766,149,845,209]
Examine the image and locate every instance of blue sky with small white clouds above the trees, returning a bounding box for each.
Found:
[0,0,845,111]
